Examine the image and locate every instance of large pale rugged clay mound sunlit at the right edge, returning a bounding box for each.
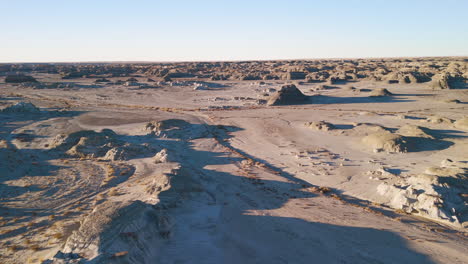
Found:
[377,160,468,228]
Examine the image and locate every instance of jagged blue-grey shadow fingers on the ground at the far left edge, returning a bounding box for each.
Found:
[0,109,89,240]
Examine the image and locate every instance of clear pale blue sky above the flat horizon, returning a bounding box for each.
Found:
[0,0,468,62]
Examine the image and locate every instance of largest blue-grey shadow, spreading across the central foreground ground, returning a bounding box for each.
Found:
[63,120,438,263]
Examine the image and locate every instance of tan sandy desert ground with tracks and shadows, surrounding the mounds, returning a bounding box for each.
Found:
[0,75,468,263]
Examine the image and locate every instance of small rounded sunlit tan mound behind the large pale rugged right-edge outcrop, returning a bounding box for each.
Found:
[362,131,408,153]
